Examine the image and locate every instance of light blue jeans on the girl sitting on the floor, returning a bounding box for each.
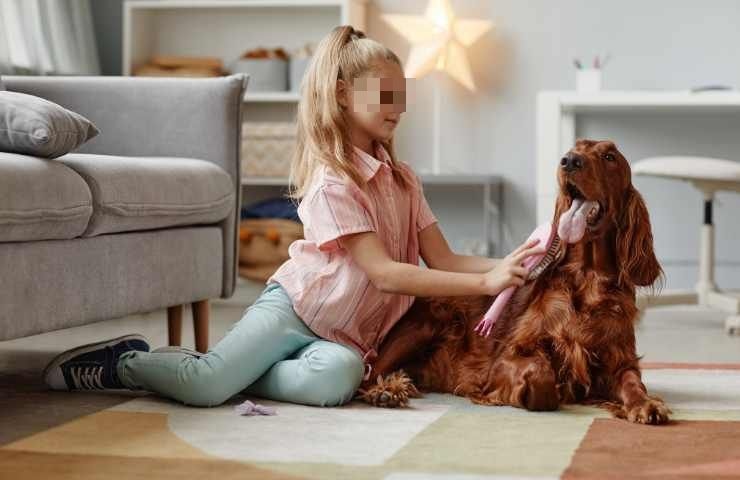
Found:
[117,283,364,407]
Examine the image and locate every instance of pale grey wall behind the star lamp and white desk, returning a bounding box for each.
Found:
[368,0,740,288]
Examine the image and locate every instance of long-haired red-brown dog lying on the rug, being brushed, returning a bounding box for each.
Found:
[359,140,670,424]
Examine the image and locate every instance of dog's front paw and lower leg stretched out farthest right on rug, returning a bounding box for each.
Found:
[609,368,672,425]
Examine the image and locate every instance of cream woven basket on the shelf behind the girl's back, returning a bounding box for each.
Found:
[242,122,296,177]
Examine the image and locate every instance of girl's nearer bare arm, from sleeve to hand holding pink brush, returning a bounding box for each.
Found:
[339,232,542,297]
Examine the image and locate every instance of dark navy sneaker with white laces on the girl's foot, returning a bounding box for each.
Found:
[44,334,149,390]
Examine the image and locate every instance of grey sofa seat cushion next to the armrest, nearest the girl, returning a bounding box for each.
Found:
[57,153,236,237]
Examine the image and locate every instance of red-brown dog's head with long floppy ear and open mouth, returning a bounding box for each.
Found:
[555,140,662,286]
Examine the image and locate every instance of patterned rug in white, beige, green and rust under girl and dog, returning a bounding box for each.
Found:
[0,364,740,480]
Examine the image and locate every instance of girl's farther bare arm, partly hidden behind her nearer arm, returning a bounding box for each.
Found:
[419,222,501,273]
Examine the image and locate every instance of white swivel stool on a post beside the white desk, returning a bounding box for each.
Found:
[632,157,740,334]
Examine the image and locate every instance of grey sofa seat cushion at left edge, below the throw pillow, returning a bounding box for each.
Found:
[0,152,93,242]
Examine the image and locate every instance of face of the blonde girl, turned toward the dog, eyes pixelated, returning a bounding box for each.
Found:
[339,62,406,147]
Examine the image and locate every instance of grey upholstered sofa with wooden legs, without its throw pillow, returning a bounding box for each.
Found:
[0,75,247,350]
